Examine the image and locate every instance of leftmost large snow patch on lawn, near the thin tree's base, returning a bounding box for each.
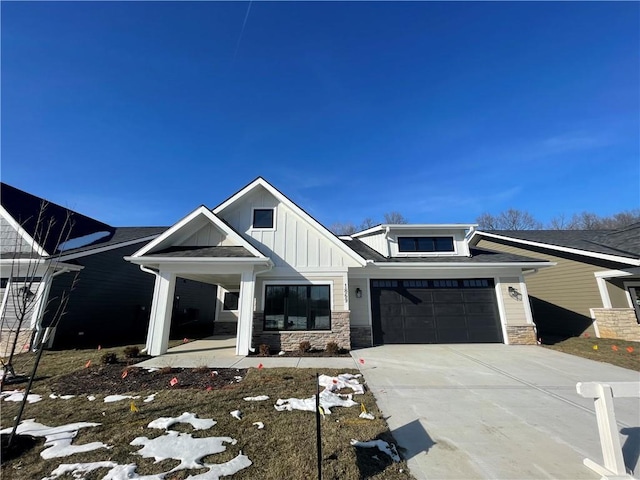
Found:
[0,419,111,460]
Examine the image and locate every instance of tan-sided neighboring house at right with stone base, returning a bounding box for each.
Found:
[471,228,640,341]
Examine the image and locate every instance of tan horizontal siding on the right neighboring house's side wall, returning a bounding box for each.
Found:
[478,238,628,335]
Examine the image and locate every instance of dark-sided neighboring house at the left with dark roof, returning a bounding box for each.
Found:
[0,183,166,355]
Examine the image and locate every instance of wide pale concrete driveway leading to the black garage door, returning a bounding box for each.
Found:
[352,344,640,480]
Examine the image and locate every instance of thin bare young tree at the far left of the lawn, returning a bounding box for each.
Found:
[0,201,77,447]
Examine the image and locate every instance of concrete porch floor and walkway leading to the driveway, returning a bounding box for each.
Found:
[135,335,358,369]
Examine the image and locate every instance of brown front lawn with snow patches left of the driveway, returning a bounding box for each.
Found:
[1,349,413,480]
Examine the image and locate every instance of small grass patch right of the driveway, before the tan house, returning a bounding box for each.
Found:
[545,336,640,371]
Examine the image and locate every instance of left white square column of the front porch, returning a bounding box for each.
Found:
[147,270,176,357]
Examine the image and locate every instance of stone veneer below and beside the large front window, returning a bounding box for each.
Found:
[253,312,351,351]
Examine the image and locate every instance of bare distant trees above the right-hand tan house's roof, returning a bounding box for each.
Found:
[476,208,640,230]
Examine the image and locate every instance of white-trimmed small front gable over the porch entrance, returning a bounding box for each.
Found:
[130,205,267,258]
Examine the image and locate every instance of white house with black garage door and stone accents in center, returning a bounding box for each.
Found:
[126,178,553,355]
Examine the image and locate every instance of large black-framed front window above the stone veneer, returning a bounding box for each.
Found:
[264,285,331,330]
